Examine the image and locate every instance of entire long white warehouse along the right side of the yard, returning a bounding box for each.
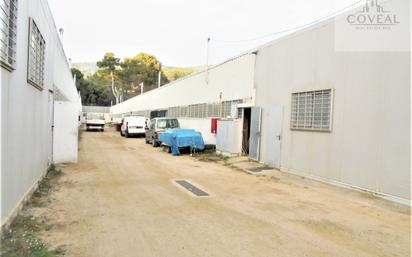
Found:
[111,1,411,205]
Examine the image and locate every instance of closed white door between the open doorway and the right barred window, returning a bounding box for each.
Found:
[263,106,283,168]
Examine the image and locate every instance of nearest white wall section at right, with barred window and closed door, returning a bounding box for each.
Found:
[255,24,411,204]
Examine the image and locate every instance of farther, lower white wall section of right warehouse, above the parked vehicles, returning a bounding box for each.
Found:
[110,53,255,144]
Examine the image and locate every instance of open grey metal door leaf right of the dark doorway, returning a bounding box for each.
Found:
[249,107,262,161]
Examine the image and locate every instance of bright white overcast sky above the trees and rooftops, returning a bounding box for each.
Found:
[49,0,356,66]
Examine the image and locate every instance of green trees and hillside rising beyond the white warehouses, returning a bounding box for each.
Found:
[72,53,200,106]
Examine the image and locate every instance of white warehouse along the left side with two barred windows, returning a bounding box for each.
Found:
[0,0,81,225]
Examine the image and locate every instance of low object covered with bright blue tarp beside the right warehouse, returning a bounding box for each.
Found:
[159,129,205,155]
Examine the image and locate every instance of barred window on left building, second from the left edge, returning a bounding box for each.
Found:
[27,19,46,89]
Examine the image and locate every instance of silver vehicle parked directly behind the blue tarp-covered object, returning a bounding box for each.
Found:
[145,117,180,147]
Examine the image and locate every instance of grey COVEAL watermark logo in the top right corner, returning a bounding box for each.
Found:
[346,0,400,30]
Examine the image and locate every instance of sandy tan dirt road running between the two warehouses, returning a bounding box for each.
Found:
[39,128,411,257]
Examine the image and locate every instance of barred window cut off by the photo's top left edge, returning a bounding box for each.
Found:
[0,0,17,69]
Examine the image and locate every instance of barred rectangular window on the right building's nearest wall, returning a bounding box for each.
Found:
[290,89,333,131]
